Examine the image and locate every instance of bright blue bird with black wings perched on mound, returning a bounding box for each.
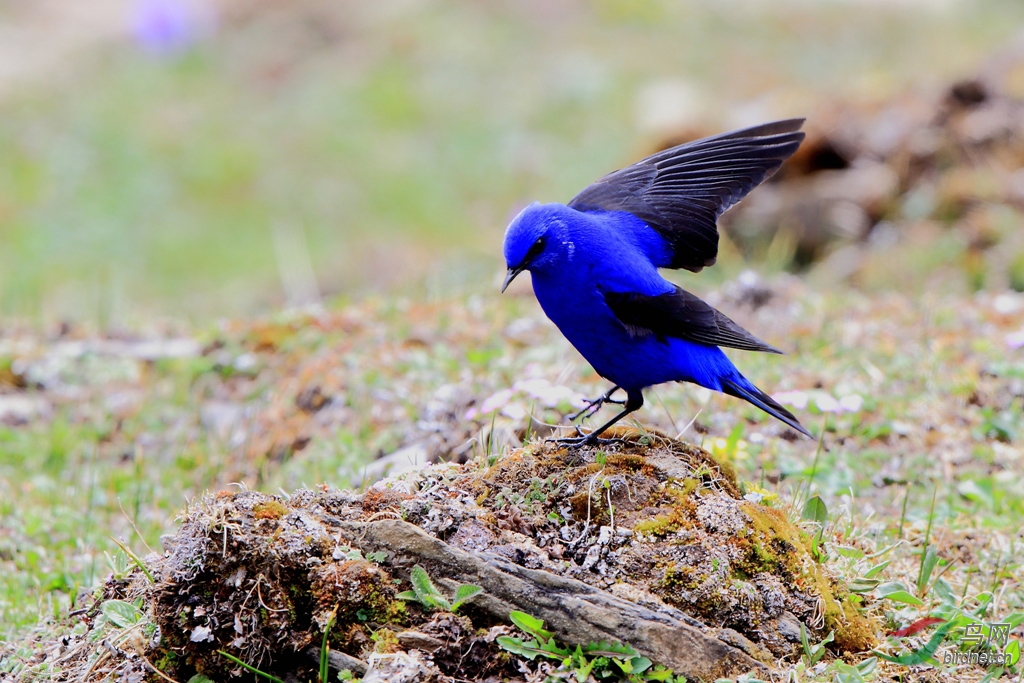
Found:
[502,119,811,445]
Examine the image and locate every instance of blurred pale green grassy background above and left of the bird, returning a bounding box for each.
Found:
[6,0,1024,328]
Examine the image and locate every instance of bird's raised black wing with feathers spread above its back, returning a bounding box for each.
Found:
[568,119,804,272]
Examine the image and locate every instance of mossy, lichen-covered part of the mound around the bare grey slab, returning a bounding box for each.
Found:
[134,429,876,680]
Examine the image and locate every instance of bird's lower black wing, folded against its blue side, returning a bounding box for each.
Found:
[604,286,782,353]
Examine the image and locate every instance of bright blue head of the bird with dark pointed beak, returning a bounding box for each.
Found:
[502,202,573,292]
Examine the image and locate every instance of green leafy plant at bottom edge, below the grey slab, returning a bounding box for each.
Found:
[498,611,686,683]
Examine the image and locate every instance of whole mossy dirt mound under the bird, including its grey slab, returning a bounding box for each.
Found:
[9,430,874,681]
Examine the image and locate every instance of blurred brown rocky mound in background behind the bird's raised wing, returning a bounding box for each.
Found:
[696,34,1024,291]
